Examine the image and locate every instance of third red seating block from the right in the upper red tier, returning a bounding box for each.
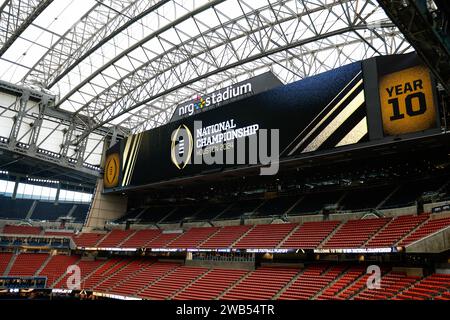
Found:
[323,218,390,248]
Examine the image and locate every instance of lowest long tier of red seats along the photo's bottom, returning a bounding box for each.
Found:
[0,253,450,300]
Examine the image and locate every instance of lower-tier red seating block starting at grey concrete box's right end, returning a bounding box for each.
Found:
[221,267,299,300]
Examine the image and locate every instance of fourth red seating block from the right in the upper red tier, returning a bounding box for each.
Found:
[281,221,340,249]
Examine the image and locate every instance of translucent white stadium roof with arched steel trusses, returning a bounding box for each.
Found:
[0,0,412,172]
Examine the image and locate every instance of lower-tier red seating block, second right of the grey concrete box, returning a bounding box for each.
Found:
[280,265,345,300]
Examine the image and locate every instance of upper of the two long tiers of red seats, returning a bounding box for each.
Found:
[4,214,450,249]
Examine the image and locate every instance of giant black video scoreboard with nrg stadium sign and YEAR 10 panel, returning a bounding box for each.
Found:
[104,54,440,192]
